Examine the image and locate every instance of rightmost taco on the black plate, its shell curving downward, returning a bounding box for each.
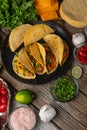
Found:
[43,34,69,65]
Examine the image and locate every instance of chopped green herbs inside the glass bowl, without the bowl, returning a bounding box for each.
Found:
[51,77,77,102]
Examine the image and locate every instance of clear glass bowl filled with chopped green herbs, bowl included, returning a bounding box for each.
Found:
[50,75,79,102]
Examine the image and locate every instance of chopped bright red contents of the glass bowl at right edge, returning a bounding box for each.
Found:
[77,46,87,64]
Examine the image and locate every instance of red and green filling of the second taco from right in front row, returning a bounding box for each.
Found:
[43,44,57,73]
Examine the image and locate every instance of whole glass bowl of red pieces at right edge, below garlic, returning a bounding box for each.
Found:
[74,44,87,65]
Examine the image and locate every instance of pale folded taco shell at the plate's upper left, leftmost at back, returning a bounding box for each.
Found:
[9,24,32,52]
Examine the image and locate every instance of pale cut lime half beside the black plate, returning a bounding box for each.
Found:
[72,66,82,79]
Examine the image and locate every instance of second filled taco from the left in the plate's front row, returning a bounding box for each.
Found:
[26,42,46,75]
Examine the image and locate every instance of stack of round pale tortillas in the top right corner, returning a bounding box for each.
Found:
[60,0,87,27]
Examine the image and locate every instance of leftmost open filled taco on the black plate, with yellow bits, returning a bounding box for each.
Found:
[12,48,36,79]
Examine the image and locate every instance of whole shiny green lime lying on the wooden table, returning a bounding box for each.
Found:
[15,89,35,104]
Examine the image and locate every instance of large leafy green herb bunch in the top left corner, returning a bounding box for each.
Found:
[0,0,37,29]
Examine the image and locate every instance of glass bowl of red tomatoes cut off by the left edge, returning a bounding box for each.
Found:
[0,78,11,130]
